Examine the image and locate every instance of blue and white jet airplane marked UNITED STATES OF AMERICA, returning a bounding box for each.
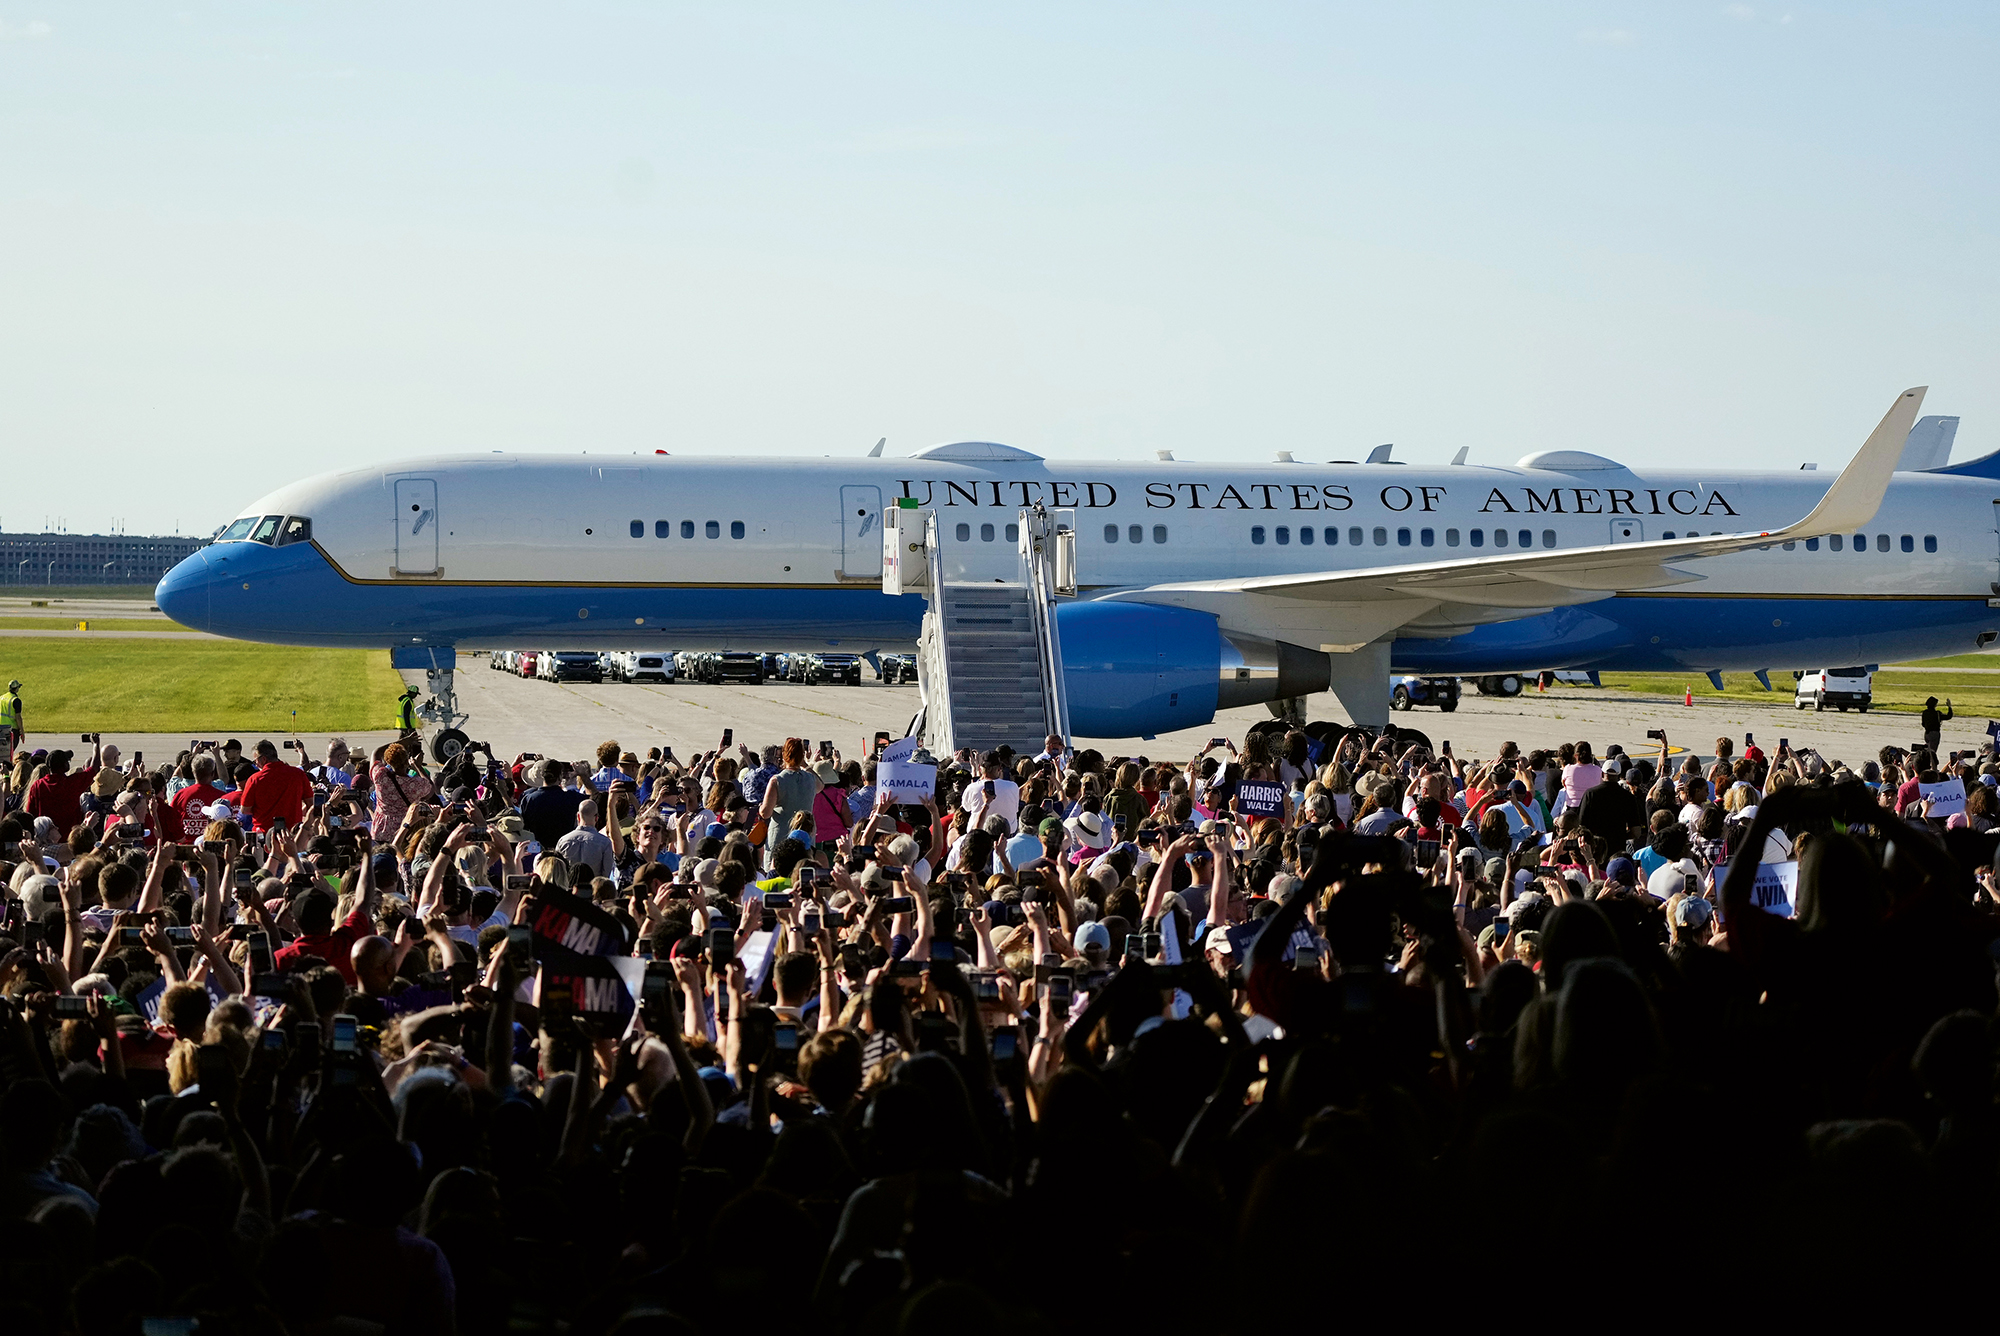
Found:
[156,388,2000,740]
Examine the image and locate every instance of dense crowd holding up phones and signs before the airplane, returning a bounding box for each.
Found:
[0,708,2000,1336]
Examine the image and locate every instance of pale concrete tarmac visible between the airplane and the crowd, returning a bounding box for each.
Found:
[28,656,1986,766]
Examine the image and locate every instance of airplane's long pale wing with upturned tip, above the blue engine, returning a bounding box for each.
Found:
[1110,386,1928,644]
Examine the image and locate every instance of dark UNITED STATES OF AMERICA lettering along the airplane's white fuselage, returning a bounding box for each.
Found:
[900,478,1736,516]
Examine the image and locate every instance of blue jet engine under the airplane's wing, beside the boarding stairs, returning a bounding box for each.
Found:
[1056,602,1332,738]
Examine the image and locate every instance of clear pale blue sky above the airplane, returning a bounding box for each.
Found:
[0,0,2000,532]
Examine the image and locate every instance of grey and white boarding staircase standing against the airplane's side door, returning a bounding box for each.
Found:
[882,504,1076,758]
